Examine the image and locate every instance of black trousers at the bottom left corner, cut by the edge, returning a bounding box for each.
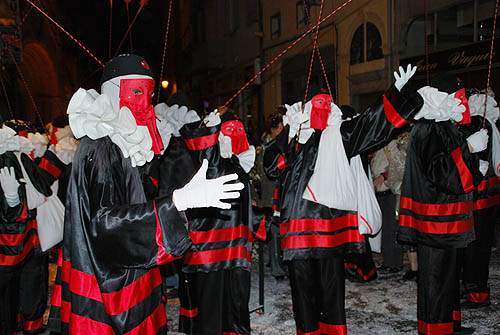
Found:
[0,265,22,335]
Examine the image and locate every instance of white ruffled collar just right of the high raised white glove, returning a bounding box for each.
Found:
[414,86,465,122]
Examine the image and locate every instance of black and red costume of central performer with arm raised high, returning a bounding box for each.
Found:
[264,86,422,334]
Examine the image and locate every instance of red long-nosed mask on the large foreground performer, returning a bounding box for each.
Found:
[120,78,163,155]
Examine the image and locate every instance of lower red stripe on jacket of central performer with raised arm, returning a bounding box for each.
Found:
[281,229,365,250]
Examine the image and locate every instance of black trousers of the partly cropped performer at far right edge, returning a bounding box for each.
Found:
[462,207,499,303]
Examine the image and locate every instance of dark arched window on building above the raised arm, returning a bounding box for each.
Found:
[350,22,384,65]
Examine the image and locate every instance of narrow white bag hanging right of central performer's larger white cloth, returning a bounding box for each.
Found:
[351,155,382,252]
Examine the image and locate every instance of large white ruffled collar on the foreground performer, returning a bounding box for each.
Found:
[68,88,154,167]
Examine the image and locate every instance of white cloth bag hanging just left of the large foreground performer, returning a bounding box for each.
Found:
[36,186,64,252]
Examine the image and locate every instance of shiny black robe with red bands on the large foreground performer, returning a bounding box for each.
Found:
[53,137,191,335]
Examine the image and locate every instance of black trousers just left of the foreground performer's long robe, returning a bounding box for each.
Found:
[19,254,49,334]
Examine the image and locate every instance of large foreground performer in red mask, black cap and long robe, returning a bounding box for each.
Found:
[47,54,243,335]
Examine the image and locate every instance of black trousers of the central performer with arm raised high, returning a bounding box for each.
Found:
[288,255,347,335]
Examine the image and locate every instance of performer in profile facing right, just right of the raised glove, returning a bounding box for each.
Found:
[398,73,488,334]
